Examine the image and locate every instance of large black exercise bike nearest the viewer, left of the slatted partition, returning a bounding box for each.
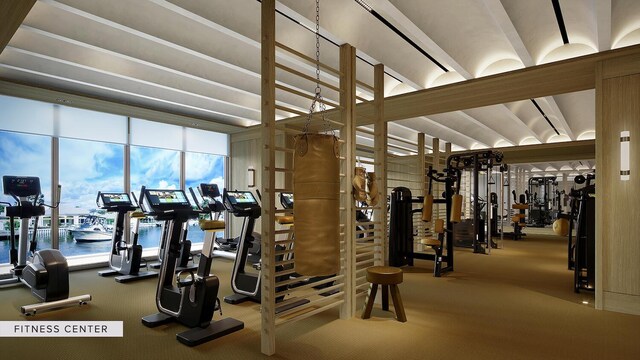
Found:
[140,186,244,346]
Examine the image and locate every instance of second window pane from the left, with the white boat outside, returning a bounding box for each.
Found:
[55,106,127,257]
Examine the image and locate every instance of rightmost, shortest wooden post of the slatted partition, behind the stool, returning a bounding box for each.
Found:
[373,64,388,265]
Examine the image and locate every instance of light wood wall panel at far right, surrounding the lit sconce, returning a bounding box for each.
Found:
[596,55,640,315]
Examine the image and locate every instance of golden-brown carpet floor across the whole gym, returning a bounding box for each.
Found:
[0,232,640,360]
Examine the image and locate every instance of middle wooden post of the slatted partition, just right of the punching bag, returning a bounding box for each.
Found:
[340,44,356,319]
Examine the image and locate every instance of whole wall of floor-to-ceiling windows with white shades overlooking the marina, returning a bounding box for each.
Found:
[0,95,228,264]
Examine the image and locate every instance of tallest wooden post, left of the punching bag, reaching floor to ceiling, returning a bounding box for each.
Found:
[260,0,276,355]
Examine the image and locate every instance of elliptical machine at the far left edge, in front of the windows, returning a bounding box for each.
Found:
[0,175,91,316]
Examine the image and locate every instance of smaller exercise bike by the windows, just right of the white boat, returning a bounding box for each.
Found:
[96,192,158,283]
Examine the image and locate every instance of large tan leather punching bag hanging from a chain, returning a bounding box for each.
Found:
[293,134,340,276]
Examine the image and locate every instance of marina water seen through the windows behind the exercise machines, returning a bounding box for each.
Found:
[0,225,204,264]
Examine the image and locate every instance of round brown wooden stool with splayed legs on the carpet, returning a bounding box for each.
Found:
[362,266,407,322]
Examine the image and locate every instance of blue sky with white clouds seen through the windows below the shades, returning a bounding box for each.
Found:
[0,131,224,214]
